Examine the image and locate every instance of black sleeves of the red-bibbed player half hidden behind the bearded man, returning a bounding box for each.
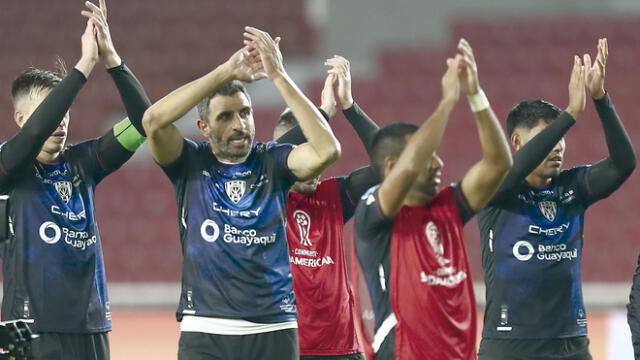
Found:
[277,102,380,222]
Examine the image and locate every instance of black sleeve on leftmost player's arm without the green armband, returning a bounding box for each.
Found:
[0,69,87,182]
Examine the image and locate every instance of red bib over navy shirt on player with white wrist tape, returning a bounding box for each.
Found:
[356,186,477,360]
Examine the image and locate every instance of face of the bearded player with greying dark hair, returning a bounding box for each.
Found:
[205,92,256,161]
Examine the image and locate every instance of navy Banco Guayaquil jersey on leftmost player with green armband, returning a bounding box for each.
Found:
[0,140,111,333]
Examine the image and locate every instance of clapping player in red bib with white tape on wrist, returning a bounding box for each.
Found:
[355,39,511,360]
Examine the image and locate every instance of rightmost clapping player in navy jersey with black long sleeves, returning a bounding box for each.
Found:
[478,39,636,360]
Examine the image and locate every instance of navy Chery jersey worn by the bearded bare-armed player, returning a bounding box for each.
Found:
[163,140,296,323]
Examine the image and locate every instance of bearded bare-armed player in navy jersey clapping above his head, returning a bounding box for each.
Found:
[143,27,340,360]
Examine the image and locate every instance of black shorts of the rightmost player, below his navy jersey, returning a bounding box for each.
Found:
[478,336,593,360]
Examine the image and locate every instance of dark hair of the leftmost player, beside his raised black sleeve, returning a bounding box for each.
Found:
[11,58,67,106]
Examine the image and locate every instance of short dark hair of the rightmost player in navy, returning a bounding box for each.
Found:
[507,100,562,136]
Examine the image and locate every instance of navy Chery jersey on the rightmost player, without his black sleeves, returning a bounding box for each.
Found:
[478,166,594,339]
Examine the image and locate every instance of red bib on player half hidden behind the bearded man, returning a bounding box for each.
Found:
[287,178,360,356]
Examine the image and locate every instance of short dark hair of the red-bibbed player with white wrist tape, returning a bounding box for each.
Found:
[371,122,418,174]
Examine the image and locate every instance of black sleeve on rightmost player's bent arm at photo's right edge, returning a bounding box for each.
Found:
[587,93,636,201]
